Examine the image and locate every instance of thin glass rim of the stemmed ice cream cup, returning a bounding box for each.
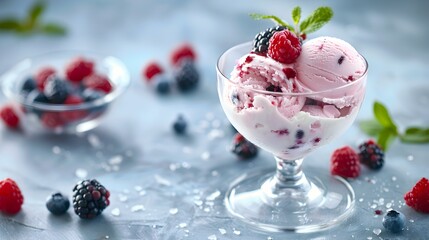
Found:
[216,41,369,96]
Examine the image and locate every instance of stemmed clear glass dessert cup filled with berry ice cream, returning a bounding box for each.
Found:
[217,43,368,232]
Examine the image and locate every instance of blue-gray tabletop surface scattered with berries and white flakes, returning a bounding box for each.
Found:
[0,0,429,240]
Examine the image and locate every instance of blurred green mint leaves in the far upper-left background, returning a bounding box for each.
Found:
[0,1,66,35]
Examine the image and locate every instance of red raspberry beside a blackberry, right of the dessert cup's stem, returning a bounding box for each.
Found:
[331,146,360,178]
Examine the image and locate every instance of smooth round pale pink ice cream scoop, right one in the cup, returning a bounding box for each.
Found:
[295,37,366,103]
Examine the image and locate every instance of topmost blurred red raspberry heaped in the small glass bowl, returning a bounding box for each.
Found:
[66,57,94,82]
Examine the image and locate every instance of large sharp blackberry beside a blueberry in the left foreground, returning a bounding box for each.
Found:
[73,179,110,219]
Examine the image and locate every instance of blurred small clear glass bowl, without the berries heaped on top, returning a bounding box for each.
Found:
[0,51,130,133]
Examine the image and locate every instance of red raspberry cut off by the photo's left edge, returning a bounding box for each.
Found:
[0,178,24,214]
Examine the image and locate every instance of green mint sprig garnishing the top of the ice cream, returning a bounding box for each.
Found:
[250,6,334,36]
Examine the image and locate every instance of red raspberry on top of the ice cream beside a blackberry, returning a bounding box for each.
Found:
[268,30,301,64]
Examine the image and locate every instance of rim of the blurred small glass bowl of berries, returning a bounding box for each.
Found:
[0,50,131,112]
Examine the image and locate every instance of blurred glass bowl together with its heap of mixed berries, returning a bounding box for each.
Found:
[0,51,130,133]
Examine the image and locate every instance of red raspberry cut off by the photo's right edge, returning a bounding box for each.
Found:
[404,178,429,213]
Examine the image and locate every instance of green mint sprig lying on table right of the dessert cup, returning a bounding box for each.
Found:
[359,102,429,151]
